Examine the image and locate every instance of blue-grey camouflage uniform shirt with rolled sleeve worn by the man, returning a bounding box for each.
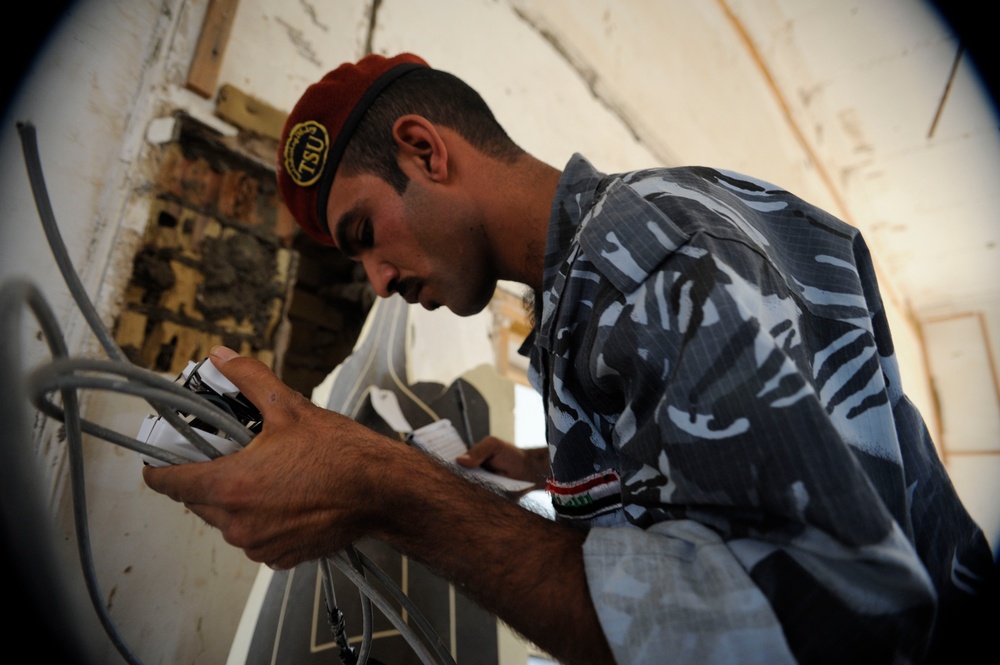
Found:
[526,155,992,664]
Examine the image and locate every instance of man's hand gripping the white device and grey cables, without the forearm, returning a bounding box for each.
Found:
[143,347,405,568]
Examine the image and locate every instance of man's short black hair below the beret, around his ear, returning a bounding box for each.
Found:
[341,67,524,194]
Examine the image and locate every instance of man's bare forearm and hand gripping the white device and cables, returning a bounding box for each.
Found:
[143,347,613,663]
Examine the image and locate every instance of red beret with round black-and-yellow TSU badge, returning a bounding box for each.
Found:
[277,53,428,245]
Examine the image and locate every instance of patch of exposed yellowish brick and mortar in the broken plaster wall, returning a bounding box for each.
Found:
[116,118,364,391]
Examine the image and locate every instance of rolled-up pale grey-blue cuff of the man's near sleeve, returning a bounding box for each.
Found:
[584,520,795,665]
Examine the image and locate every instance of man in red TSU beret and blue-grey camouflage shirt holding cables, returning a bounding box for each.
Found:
[144,54,992,663]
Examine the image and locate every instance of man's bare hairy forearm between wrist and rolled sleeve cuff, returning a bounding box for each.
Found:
[373,440,614,663]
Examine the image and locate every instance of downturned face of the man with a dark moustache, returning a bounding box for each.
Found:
[327,173,497,316]
